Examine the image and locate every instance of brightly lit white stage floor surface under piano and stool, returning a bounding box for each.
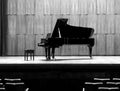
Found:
[0,56,120,64]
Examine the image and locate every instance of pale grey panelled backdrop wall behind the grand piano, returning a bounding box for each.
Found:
[6,0,120,55]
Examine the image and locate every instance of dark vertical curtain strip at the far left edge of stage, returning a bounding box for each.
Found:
[0,0,8,56]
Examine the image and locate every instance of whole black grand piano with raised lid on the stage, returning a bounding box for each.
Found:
[38,18,94,60]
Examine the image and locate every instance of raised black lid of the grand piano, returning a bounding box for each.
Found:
[51,18,94,38]
